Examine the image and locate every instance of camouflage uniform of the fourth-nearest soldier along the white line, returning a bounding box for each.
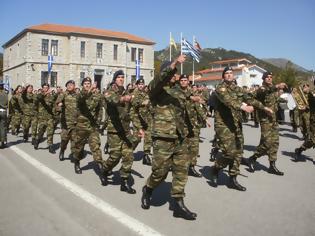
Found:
[56,91,78,157]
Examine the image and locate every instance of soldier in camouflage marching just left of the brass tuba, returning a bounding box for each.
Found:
[247,71,286,175]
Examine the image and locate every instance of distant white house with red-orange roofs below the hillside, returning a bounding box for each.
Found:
[195,58,266,88]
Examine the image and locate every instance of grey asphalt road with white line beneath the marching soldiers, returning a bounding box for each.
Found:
[0,113,315,236]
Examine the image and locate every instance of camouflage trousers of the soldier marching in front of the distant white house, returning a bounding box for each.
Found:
[214,124,244,176]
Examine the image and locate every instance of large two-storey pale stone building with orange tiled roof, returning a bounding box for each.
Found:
[2,24,155,88]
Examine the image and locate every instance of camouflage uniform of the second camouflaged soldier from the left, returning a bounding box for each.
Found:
[21,91,37,143]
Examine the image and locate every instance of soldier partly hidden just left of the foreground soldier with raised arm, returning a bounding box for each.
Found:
[132,79,152,165]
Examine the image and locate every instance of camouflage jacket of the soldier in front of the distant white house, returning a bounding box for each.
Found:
[215,81,264,132]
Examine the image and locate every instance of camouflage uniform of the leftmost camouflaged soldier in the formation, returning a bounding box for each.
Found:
[10,94,23,134]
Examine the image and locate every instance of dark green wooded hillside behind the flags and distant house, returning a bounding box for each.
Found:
[154,44,310,78]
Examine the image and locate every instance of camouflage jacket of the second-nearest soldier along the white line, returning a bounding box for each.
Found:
[105,86,131,135]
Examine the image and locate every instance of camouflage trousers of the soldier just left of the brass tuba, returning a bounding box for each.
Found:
[253,122,279,161]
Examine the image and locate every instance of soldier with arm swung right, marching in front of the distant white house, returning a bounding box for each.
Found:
[213,67,272,191]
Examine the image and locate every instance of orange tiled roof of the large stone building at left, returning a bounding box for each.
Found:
[3,24,155,47]
